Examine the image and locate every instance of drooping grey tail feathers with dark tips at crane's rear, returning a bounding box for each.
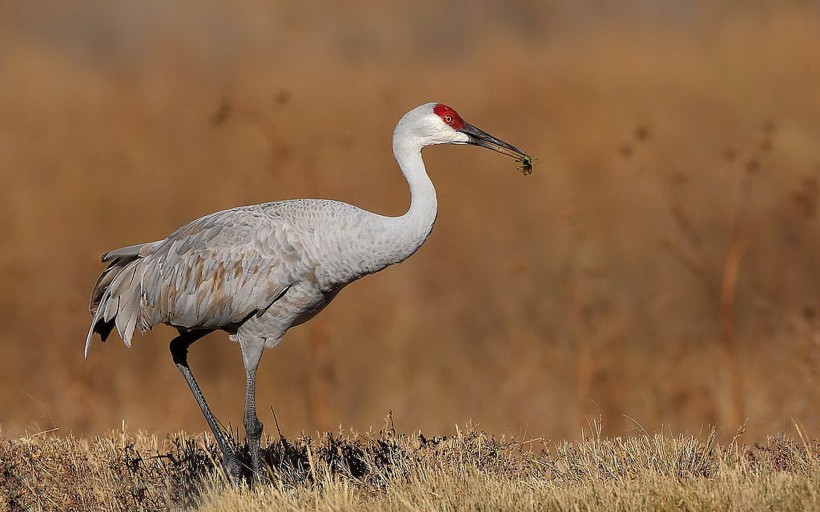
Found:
[85,243,155,359]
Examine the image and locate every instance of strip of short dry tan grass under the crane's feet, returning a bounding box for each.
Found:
[0,426,820,512]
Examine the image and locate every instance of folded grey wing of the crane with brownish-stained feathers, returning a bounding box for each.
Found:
[140,207,312,329]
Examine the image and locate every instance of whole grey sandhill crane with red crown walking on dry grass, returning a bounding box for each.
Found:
[84,103,532,481]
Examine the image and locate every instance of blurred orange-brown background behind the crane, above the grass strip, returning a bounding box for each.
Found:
[0,0,820,438]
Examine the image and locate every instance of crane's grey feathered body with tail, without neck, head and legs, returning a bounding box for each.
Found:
[86,199,435,350]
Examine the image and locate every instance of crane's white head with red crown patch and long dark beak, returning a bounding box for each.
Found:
[393,103,532,173]
